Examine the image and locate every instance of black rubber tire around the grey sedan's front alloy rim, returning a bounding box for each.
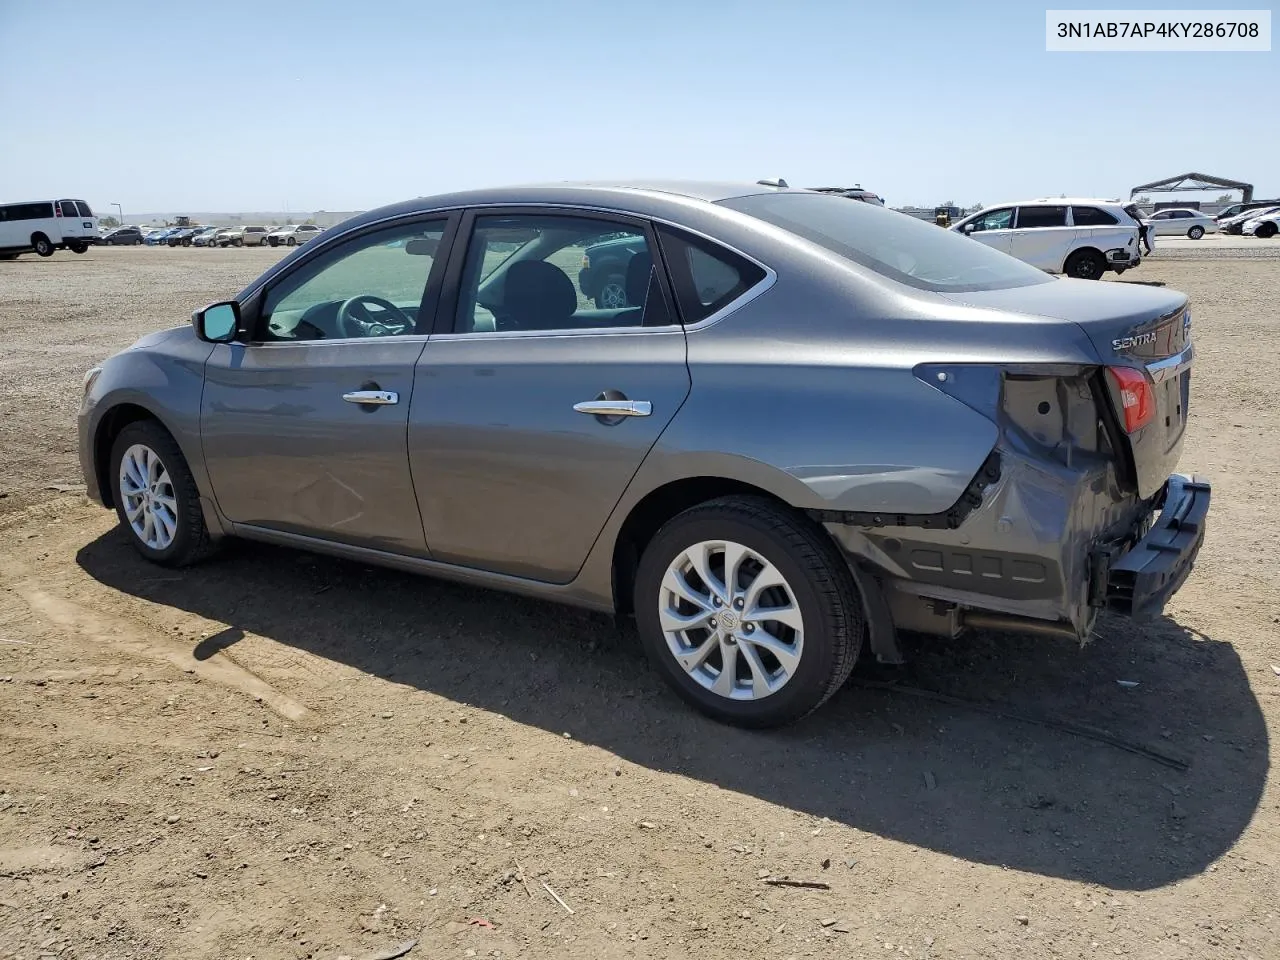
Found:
[109,420,214,567]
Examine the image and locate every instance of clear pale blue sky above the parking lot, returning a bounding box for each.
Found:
[0,0,1280,214]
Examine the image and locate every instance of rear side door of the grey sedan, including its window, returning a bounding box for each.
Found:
[408,212,689,584]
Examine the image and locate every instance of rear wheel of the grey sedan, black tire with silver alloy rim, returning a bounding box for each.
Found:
[635,497,865,727]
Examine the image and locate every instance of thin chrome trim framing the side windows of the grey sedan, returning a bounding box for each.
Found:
[237,201,778,346]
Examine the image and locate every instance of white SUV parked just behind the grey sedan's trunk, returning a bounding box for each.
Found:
[951,197,1142,280]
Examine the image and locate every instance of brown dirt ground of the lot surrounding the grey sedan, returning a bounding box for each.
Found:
[0,248,1280,960]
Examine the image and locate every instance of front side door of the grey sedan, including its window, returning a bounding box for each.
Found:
[201,219,445,554]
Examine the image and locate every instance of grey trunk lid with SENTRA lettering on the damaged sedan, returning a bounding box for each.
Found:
[942,279,1193,498]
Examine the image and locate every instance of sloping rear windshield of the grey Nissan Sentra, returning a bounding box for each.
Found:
[721,193,1051,293]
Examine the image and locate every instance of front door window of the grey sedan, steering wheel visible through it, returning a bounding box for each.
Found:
[261,220,445,340]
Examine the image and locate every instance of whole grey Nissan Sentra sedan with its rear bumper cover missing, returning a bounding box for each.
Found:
[78,182,1211,727]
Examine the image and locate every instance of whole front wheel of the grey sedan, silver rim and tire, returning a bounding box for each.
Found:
[110,420,212,567]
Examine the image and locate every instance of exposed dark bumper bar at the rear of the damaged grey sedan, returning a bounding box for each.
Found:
[1093,474,1212,620]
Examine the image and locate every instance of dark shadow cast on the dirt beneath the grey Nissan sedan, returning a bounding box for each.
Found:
[77,530,1268,890]
